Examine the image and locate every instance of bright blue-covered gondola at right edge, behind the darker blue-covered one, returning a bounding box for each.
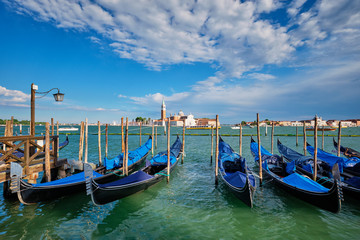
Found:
[306,143,360,177]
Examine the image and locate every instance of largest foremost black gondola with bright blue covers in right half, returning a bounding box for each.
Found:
[250,138,342,213]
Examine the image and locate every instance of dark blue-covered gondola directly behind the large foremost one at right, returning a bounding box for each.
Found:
[277,139,360,200]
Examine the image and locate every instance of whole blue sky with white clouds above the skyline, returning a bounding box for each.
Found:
[0,0,360,123]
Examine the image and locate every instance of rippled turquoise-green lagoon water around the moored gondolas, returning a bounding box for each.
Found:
[0,126,360,239]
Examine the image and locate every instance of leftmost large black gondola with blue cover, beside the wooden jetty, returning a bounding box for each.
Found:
[10,136,152,204]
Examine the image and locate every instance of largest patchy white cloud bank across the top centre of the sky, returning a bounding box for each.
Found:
[6,0,294,78]
